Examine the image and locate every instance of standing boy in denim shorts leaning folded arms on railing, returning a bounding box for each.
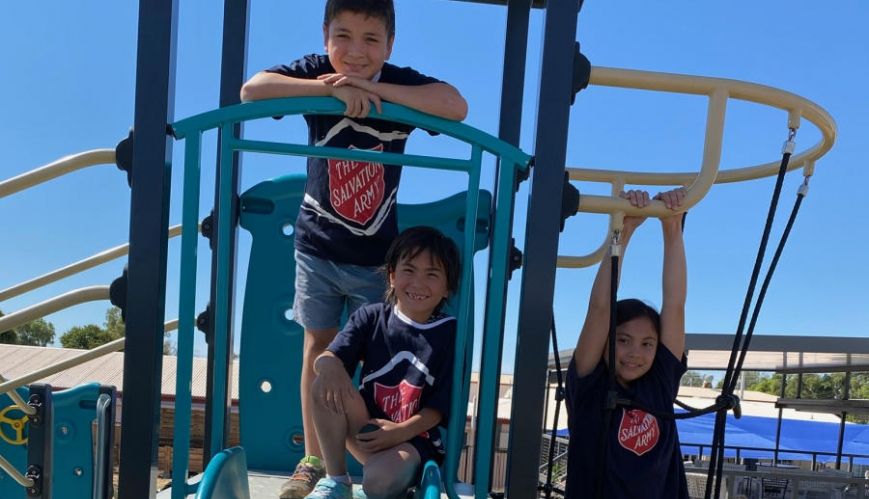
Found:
[241,0,467,498]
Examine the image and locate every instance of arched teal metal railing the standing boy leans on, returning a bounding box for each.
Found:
[172,97,531,499]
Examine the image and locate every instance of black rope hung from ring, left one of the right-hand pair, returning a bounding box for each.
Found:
[704,140,794,499]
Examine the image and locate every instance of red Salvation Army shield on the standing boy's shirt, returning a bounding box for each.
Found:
[328,144,386,225]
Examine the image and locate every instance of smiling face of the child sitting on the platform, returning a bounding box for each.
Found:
[389,251,449,323]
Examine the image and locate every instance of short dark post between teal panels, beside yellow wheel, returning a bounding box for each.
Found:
[26,383,54,499]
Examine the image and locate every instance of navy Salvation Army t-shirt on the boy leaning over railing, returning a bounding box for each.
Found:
[266,54,439,266]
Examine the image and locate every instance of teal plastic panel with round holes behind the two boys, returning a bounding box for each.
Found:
[239,175,491,472]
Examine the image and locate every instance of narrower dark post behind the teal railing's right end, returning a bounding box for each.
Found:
[471,0,531,490]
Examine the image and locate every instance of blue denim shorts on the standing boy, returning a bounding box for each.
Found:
[293,250,386,330]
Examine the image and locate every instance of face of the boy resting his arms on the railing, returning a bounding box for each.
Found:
[323,10,394,80]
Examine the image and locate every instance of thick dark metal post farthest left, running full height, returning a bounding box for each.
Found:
[118,0,178,499]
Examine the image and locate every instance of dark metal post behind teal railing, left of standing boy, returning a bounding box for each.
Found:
[202,0,250,466]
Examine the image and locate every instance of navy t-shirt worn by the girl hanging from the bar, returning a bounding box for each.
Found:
[566,343,688,499]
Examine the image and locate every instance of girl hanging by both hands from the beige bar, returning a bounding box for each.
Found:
[565,189,688,499]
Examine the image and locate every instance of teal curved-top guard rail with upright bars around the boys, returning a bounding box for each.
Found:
[172,97,531,498]
